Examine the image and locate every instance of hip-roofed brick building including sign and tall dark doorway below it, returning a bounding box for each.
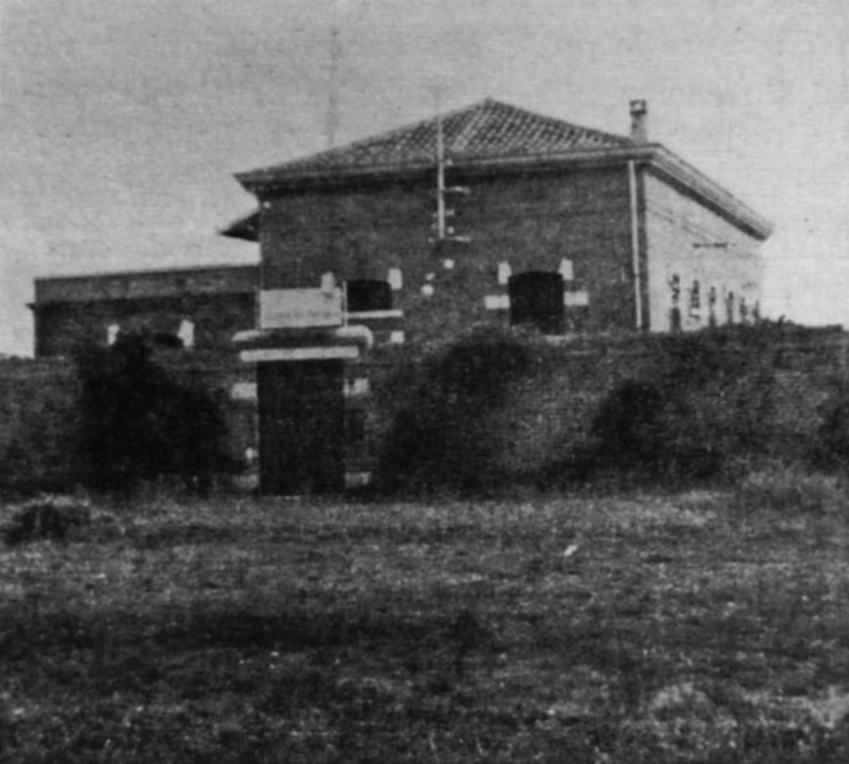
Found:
[224,100,771,494]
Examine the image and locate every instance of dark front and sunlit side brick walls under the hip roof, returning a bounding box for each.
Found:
[260,163,760,342]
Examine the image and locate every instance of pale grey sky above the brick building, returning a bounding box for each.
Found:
[0,0,849,355]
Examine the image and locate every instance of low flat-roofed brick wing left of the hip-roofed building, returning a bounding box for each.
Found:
[30,265,259,358]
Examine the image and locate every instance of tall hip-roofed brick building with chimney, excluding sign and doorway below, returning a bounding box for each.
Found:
[224,100,771,341]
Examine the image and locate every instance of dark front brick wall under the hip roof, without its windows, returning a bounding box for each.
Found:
[261,167,634,340]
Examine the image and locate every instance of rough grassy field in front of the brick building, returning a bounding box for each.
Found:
[0,486,849,764]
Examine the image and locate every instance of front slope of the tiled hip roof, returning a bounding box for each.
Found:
[236,99,634,184]
